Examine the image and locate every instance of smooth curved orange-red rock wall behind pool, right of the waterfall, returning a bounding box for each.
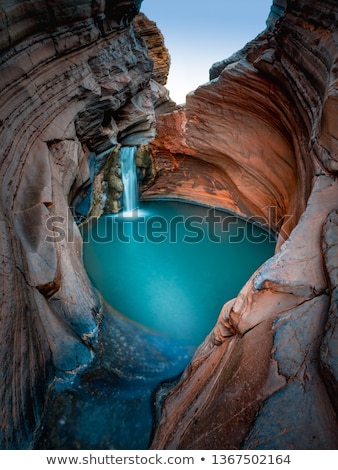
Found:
[144,61,298,237]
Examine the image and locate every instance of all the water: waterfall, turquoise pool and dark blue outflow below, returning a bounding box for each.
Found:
[81,191,275,450]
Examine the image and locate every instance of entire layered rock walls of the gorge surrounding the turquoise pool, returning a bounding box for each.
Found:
[0,0,338,449]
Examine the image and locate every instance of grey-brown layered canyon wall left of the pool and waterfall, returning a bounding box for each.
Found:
[0,0,172,449]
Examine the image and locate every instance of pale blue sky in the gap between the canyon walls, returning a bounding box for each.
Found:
[141,0,272,104]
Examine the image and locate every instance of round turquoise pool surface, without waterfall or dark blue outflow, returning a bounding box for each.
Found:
[83,201,275,346]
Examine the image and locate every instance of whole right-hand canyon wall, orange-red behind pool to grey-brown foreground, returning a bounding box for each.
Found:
[145,0,338,449]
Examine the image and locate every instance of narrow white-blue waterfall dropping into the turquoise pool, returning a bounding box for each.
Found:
[120,147,138,214]
